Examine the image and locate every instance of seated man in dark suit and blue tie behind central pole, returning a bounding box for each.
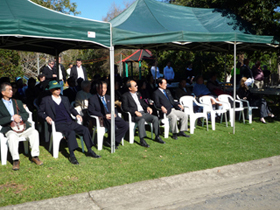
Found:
[88,81,128,149]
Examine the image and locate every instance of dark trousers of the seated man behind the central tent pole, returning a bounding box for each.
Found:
[104,117,128,145]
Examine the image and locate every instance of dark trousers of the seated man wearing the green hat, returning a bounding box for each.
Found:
[55,121,93,152]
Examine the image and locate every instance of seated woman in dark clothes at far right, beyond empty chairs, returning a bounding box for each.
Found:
[237,77,274,124]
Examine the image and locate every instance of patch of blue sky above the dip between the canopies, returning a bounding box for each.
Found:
[71,0,133,20]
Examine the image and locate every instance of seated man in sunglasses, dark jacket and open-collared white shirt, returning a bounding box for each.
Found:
[122,80,165,147]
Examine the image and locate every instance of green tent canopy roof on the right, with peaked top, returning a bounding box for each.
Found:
[110,0,278,51]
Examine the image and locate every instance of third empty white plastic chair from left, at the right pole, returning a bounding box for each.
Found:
[218,94,245,127]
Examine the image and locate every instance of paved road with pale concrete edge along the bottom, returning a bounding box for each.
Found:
[0,156,280,210]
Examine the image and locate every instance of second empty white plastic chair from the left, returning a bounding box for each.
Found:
[199,96,228,130]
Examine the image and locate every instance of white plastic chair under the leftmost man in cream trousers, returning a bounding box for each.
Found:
[0,104,35,165]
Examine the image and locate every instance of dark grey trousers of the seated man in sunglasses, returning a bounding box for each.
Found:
[135,112,159,138]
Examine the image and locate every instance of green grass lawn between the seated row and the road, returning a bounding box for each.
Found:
[0,114,280,206]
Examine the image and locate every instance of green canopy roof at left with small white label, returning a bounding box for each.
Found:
[0,0,111,55]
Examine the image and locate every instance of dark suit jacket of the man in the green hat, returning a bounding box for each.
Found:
[38,96,78,138]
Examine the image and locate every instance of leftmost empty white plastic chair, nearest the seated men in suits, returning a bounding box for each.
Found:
[180,96,208,134]
